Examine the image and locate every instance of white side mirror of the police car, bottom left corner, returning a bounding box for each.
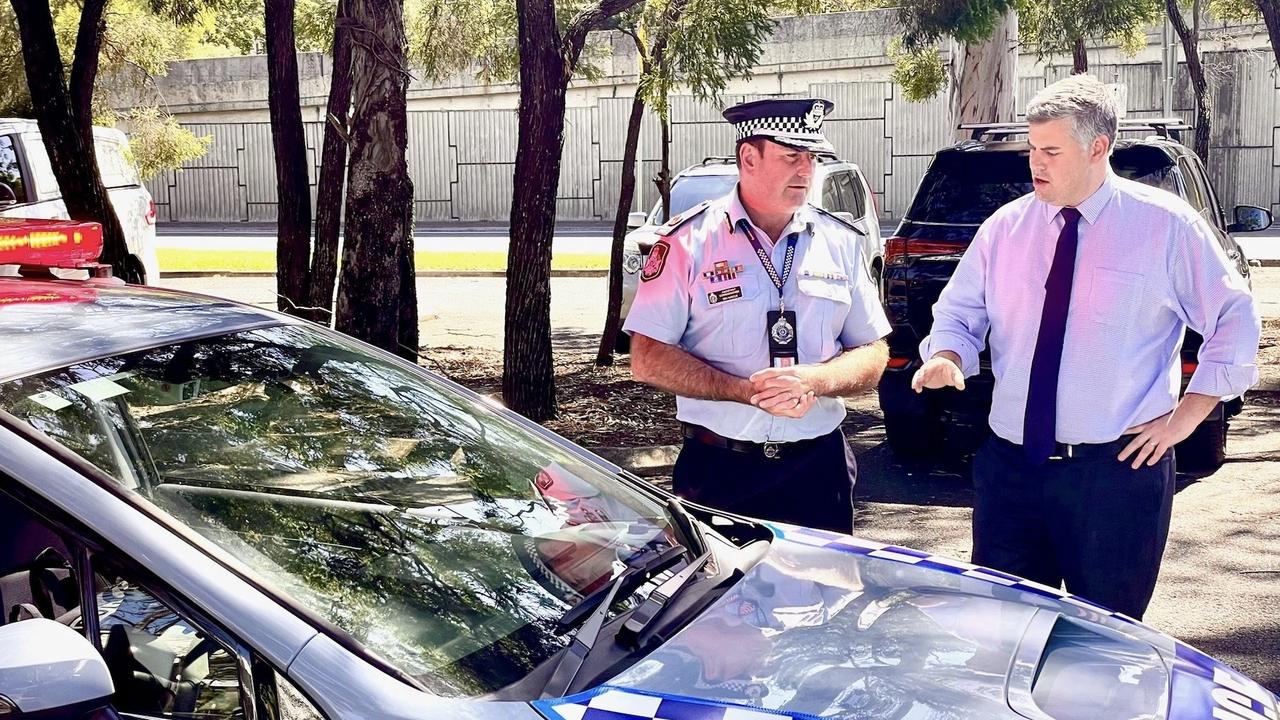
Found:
[0,618,115,719]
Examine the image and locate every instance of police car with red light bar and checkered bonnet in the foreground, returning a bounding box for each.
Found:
[0,222,1277,720]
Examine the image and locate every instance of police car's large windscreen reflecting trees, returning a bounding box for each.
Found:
[0,325,675,697]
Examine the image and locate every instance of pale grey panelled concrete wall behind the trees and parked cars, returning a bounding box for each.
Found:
[132,12,1280,222]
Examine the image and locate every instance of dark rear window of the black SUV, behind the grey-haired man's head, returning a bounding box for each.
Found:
[906,145,1181,225]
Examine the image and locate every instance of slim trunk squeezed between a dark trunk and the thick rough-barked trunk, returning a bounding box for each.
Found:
[308,0,351,325]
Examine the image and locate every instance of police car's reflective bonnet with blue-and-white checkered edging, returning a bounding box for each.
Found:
[534,525,1276,720]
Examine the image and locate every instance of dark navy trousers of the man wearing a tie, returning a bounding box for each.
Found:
[973,436,1174,620]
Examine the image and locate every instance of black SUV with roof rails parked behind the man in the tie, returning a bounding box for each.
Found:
[879,119,1271,473]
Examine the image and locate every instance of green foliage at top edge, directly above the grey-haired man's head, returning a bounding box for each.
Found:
[1018,0,1165,59]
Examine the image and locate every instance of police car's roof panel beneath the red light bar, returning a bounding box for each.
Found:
[0,278,285,382]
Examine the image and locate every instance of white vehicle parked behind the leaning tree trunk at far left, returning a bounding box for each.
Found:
[0,118,160,283]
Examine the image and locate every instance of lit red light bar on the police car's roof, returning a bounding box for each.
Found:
[0,218,102,268]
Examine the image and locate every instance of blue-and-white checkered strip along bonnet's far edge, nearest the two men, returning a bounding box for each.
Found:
[769,524,1137,623]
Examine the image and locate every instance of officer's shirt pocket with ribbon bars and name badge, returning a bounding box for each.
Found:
[696,269,765,359]
